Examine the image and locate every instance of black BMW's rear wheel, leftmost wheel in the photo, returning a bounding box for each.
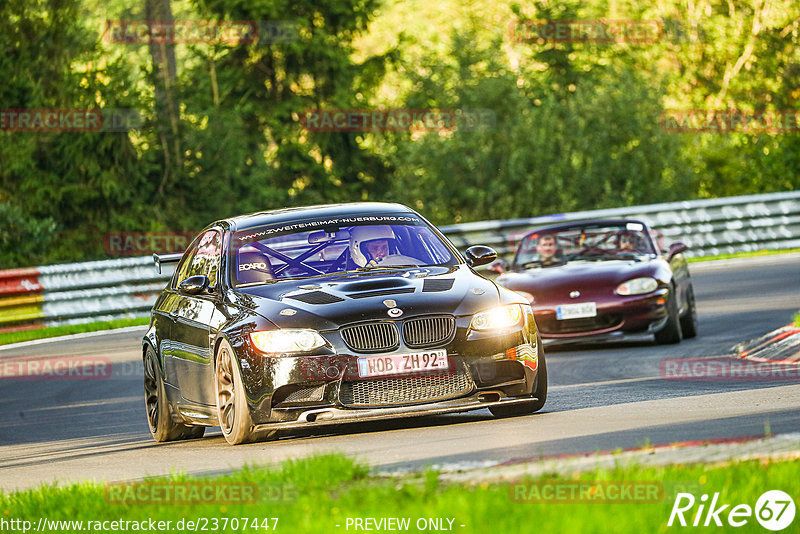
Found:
[143,346,206,442]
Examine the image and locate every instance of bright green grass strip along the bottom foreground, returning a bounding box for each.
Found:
[0,455,800,534]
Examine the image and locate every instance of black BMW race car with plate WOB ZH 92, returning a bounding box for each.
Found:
[142,203,547,444]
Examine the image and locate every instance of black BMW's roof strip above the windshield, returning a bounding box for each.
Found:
[220,202,417,231]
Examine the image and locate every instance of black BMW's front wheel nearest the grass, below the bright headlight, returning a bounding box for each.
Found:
[214,340,274,445]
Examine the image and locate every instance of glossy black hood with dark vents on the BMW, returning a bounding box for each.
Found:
[236,265,500,331]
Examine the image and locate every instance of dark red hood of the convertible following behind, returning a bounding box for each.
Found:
[497,259,669,301]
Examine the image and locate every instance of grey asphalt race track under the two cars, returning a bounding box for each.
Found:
[0,254,800,490]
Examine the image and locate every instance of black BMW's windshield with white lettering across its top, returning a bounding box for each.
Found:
[231,216,458,287]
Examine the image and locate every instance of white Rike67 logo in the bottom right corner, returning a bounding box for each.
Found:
[667,490,796,532]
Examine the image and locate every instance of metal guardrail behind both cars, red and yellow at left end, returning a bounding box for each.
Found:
[0,191,800,331]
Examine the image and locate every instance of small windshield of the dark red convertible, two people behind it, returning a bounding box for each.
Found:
[514,222,656,267]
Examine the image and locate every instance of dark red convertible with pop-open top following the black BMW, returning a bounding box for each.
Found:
[495,220,697,344]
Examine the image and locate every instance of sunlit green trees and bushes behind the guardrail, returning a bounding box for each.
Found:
[0,0,800,267]
